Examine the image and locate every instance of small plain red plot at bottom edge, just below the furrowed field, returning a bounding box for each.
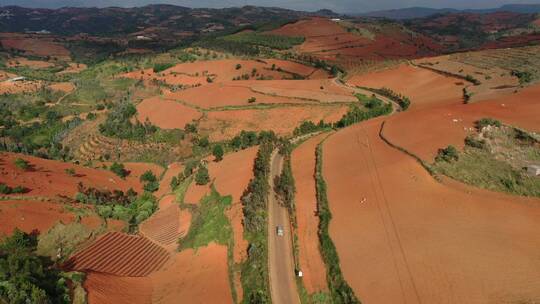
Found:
[83,271,153,304]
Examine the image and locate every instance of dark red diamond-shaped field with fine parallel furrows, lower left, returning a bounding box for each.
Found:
[64,232,169,277]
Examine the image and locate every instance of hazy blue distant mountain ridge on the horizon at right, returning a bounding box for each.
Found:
[358,4,540,20]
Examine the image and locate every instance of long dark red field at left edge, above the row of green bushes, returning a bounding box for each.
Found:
[0,153,146,198]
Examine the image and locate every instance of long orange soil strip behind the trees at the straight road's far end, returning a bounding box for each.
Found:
[199,105,348,141]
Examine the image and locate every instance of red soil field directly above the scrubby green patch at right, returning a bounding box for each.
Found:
[385,85,540,162]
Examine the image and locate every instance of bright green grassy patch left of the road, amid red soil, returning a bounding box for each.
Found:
[179,187,232,249]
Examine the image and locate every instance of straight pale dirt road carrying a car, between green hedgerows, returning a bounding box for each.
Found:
[268,149,300,304]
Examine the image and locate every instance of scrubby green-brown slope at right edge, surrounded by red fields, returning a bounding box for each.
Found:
[433,119,540,197]
